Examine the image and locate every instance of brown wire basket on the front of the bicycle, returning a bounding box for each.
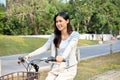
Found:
[0,71,40,80]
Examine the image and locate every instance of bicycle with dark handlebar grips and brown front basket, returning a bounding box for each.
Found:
[0,57,59,80]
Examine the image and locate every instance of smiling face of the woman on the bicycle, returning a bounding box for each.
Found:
[56,16,69,31]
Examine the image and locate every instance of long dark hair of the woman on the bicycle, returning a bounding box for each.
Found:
[54,12,73,48]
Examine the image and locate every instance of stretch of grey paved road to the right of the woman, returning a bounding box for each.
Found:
[80,40,120,59]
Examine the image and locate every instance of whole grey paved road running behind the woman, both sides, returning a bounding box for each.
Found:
[0,41,120,75]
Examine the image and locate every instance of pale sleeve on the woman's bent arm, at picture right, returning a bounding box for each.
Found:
[62,32,80,59]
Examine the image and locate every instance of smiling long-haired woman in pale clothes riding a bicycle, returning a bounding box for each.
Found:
[25,12,79,80]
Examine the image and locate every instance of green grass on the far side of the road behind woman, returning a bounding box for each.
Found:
[0,35,98,56]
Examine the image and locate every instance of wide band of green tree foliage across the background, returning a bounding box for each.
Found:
[0,0,120,35]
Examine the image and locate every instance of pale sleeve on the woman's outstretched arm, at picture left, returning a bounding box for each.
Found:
[29,34,54,57]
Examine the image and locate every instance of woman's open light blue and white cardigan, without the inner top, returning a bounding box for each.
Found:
[29,31,80,66]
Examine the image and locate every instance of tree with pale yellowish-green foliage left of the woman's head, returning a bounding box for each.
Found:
[6,0,48,34]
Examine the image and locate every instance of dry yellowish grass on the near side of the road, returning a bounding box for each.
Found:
[41,53,120,80]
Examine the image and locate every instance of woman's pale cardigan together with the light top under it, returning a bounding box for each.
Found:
[29,31,80,65]
